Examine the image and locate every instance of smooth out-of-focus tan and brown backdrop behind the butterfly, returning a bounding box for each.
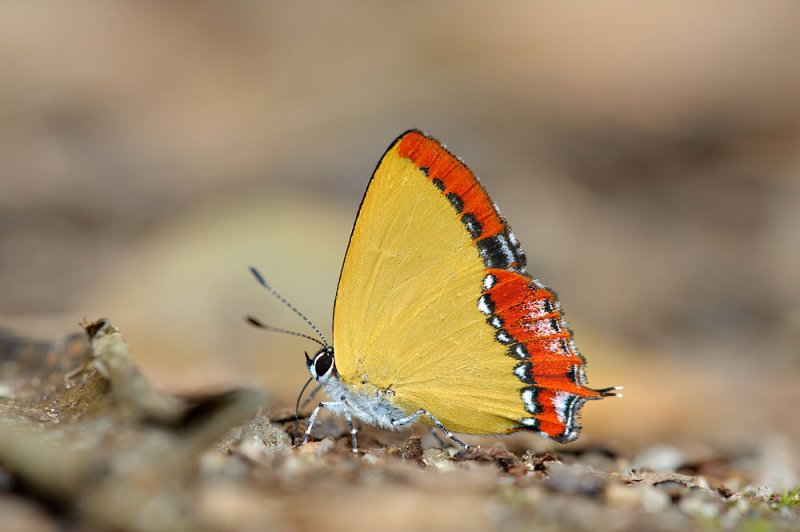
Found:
[0,1,800,456]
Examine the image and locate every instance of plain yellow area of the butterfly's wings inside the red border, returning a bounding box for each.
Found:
[334,132,530,434]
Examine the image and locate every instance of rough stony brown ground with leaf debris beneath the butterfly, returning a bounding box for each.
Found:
[0,321,800,531]
